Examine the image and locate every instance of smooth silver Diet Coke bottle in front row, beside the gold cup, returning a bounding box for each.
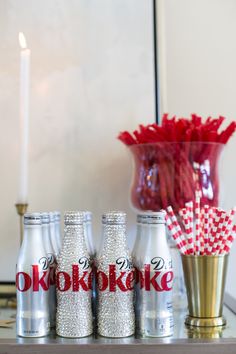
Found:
[133,212,174,337]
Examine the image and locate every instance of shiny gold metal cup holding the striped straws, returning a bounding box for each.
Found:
[182,255,228,327]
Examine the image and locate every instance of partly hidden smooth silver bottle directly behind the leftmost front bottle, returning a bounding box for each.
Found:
[41,213,56,327]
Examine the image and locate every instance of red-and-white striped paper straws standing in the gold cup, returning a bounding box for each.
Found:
[166,193,236,256]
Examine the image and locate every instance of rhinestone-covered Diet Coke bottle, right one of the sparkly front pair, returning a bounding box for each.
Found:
[96,212,135,338]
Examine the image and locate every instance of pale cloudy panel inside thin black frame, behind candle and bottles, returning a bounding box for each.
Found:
[0,0,154,280]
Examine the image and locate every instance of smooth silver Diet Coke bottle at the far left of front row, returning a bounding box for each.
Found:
[16,213,50,337]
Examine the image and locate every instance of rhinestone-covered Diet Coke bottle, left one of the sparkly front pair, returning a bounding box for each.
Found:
[56,212,93,338]
